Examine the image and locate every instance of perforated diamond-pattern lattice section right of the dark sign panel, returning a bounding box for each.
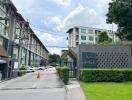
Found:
[96,52,129,68]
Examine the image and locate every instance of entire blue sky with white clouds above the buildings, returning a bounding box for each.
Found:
[12,0,116,54]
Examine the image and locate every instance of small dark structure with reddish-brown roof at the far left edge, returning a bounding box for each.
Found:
[0,46,8,79]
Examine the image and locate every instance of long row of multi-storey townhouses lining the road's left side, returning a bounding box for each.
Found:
[0,0,49,78]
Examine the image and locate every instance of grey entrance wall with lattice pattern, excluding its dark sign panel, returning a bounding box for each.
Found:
[78,45,132,68]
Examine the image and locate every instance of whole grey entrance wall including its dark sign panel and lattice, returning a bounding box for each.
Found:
[76,44,132,75]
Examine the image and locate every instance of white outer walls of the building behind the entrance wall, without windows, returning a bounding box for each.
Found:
[69,26,118,47]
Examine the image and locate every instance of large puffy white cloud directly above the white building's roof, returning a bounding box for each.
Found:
[63,5,101,28]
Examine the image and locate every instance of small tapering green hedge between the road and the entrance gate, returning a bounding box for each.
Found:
[56,67,69,85]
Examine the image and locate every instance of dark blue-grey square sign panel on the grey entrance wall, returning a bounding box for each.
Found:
[82,52,97,68]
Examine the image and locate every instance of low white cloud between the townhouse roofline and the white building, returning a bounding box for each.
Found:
[34,30,66,55]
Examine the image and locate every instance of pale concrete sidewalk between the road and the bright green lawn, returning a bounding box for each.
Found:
[66,80,86,100]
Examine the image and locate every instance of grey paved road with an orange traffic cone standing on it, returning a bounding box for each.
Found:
[0,68,66,100]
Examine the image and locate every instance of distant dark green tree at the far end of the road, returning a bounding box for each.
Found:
[49,54,60,65]
